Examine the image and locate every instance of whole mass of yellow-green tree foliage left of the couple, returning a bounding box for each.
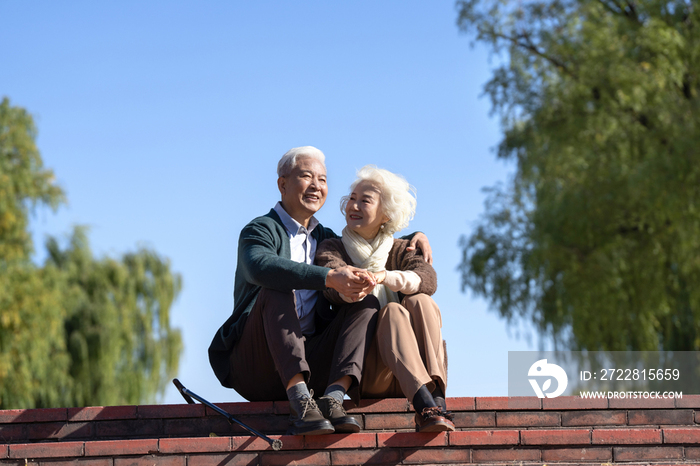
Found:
[0,98,182,408]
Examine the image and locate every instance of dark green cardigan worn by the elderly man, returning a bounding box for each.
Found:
[209,209,338,388]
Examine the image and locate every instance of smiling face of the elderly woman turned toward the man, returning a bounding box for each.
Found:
[345,181,389,241]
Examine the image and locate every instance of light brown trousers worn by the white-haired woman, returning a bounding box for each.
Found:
[361,294,447,400]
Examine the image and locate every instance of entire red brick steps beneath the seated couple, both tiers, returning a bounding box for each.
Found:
[0,396,700,466]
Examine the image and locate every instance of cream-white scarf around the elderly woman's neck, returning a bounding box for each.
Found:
[341,227,399,307]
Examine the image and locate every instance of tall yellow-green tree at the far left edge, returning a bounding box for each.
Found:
[0,98,69,408]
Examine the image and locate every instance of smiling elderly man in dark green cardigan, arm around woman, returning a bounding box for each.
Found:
[209,146,430,435]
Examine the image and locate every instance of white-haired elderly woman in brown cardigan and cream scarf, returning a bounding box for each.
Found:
[316,165,454,432]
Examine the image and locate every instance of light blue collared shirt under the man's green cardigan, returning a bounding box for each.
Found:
[274,202,318,335]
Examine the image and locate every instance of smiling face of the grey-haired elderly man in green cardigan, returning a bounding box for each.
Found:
[277,157,328,225]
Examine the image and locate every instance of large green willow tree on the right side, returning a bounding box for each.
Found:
[457,0,700,350]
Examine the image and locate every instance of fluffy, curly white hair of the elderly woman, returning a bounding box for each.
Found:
[340,165,416,235]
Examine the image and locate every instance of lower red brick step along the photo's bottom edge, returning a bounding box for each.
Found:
[0,429,700,466]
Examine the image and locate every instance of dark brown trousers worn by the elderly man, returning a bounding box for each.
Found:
[227,288,379,402]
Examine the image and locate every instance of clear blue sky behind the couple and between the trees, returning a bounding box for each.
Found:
[0,0,536,403]
